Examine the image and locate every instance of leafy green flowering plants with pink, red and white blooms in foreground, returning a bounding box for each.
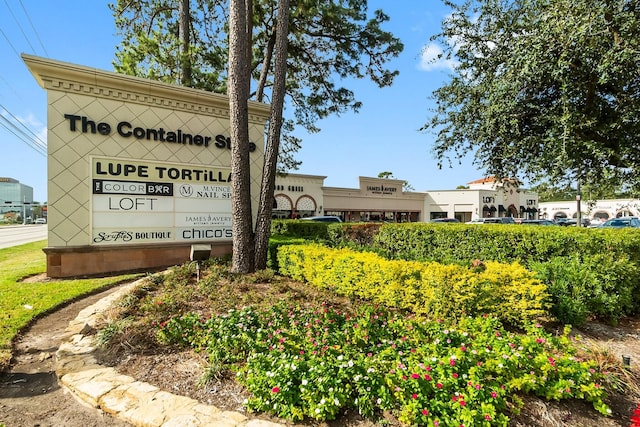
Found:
[159,303,610,426]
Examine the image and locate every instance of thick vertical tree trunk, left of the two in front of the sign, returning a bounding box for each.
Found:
[228,0,255,273]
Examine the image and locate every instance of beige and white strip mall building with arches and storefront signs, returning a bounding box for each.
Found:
[273,174,538,226]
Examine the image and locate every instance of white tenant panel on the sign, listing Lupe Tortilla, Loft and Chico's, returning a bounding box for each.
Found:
[91,157,232,245]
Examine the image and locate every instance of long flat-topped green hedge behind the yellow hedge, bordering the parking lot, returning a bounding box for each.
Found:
[374,223,640,265]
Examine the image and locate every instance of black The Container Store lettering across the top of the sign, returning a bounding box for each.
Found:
[64,114,256,152]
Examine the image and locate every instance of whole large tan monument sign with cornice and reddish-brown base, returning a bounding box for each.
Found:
[23,55,269,277]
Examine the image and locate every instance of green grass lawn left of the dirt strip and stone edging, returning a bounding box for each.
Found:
[0,240,137,370]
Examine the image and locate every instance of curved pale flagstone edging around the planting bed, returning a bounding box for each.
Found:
[55,279,283,427]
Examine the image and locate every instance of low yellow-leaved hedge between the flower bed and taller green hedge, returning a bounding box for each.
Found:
[278,244,548,325]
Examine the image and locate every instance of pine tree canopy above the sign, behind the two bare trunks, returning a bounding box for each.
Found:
[110,0,403,169]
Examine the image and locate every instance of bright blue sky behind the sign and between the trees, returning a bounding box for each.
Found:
[0,0,484,202]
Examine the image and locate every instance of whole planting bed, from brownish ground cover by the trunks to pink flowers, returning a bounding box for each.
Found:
[96,265,640,427]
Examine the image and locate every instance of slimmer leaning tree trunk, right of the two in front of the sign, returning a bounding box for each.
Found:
[255,0,289,270]
